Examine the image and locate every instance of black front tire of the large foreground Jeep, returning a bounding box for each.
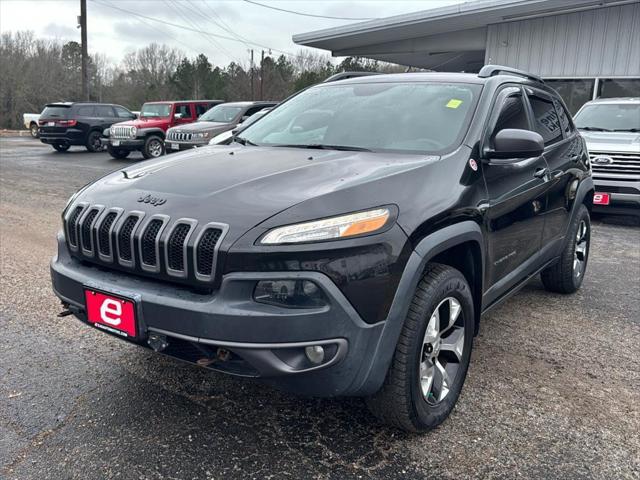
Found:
[366,263,475,432]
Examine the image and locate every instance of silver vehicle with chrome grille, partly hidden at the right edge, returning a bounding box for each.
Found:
[574,98,640,216]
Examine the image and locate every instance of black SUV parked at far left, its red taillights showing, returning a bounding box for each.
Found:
[38,102,136,152]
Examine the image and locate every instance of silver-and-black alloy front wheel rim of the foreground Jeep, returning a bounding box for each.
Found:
[419,297,465,405]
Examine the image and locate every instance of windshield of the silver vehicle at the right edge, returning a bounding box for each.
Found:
[574,103,640,132]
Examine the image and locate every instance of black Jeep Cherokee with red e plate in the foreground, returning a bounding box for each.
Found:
[51,66,593,431]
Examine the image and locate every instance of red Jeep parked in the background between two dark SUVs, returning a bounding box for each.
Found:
[102,100,224,158]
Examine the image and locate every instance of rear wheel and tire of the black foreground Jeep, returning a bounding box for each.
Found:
[540,204,591,293]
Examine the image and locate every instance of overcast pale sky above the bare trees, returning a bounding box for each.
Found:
[0,0,462,65]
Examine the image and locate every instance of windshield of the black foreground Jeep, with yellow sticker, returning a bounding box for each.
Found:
[240,82,481,153]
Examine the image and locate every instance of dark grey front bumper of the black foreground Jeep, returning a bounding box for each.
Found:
[51,238,384,396]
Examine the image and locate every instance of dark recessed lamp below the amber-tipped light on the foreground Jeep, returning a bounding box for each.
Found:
[253,280,327,308]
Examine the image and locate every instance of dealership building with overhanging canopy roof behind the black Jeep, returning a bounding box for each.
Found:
[293,0,640,113]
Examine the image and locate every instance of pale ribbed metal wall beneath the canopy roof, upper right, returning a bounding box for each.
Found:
[485,1,640,78]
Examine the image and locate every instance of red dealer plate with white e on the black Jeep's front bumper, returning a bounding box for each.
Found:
[84,290,137,337]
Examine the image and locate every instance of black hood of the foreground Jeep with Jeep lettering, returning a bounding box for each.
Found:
[78,146,439,242]
